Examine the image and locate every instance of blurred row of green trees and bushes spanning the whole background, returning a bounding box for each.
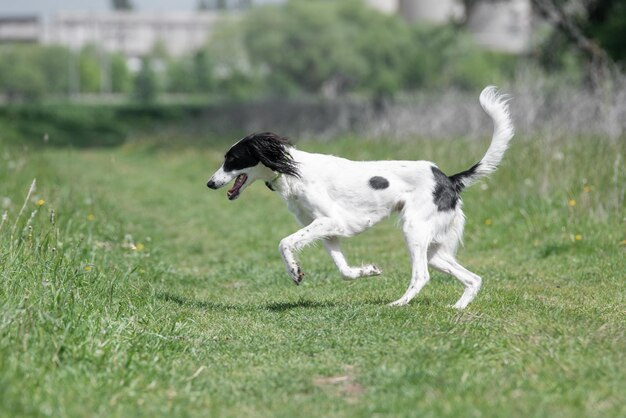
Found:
[0,0,626,102]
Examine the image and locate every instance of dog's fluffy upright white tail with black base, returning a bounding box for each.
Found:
[450,86,514,191]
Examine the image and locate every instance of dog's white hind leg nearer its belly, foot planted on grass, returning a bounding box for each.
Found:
[389,221,431,306]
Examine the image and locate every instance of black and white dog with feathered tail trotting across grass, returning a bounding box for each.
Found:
[207,86,513,309]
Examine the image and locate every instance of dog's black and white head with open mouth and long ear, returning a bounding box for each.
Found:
[207,132,298,200]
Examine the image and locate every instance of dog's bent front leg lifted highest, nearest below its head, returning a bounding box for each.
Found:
[278,218,345,284]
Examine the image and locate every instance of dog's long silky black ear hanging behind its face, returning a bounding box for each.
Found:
[249,132,300,177]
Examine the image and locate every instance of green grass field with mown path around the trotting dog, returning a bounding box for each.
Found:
[0,135,626,417]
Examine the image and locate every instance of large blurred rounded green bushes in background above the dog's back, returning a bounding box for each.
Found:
[241,0,516,97]
